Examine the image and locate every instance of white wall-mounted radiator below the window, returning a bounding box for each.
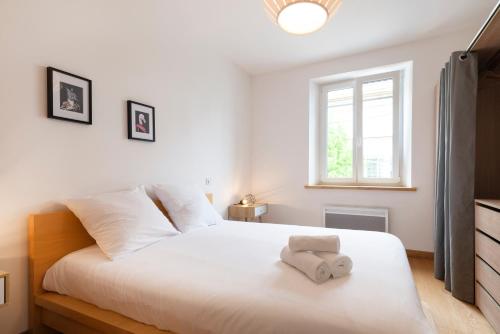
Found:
[323,206,389,232]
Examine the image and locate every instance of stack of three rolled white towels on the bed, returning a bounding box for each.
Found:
[281,235,352,283]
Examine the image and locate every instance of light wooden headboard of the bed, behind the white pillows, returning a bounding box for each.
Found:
[29,194,213,324]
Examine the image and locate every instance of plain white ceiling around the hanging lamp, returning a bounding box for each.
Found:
[172,0,496,74]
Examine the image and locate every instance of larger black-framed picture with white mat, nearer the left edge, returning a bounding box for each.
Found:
[47,67,92,124]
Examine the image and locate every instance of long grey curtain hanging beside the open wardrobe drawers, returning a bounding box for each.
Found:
[434,52,478,303]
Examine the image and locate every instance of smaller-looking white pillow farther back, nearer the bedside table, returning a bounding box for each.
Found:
[154,185,223,232]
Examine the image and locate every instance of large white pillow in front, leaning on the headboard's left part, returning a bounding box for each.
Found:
[65,188,179,259]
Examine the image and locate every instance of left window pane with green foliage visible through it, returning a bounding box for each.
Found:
[327,88,354,178]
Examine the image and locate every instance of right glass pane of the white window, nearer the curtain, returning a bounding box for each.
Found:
[363,79,394,178]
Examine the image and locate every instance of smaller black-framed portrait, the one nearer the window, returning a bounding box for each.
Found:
[127,100,155,141]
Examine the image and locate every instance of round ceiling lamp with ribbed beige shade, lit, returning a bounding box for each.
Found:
[264,0,342,35]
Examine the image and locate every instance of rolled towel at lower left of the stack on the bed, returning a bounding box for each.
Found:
[280,247,332,283]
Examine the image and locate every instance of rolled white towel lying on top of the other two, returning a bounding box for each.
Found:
[288,235,340,253]
